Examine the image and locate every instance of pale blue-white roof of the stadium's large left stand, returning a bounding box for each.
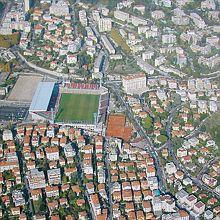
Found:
[29,82,55,112]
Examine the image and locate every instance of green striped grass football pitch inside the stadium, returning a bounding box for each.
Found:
[56,93,99,123]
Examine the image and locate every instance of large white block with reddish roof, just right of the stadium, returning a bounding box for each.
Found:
[122,73,147,94]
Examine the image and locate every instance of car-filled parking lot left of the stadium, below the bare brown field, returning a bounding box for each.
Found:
[0,106,29,121]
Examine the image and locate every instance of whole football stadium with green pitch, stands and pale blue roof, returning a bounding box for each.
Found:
[29,82,109,129]
